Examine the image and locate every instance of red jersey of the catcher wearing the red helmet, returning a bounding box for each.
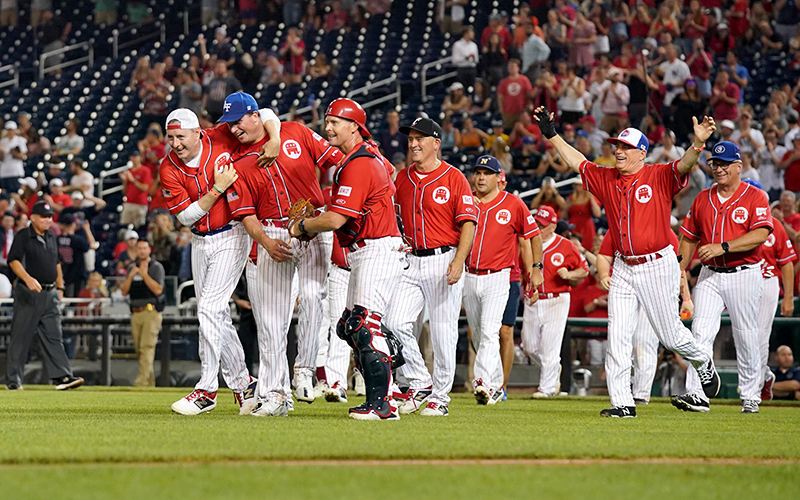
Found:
[331,142,400,246]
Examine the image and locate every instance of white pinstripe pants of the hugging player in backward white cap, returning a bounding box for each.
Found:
[192,223,250,393]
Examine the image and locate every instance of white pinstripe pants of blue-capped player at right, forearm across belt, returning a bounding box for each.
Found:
[686,265,764,402]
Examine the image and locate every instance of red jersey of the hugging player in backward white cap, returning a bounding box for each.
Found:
[159,124,239,233]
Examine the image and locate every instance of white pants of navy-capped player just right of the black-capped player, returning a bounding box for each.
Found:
[464,269,511,390]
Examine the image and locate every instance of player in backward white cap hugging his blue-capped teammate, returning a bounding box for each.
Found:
[159,108,280,415]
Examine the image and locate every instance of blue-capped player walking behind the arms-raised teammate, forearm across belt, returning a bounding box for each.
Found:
[672,141,772,413]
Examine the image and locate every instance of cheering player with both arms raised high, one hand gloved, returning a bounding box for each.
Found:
[534,107,720,418]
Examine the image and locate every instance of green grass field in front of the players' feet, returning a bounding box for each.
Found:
[0,386,800,500]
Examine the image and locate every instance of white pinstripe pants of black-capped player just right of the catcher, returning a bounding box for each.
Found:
[386,248,464,404]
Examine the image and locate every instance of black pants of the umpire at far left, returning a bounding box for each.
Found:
[6,283,72,385]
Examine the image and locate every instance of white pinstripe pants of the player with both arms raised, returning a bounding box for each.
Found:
[606,247,711,406]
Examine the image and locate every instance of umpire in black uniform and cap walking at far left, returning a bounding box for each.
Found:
[6,201,83,391]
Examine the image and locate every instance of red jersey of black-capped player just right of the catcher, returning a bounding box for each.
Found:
[395,162,478,250]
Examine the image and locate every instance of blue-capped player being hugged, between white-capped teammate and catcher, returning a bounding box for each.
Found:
[220,92,342,416]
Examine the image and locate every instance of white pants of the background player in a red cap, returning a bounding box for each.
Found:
[522,293,571,394]
